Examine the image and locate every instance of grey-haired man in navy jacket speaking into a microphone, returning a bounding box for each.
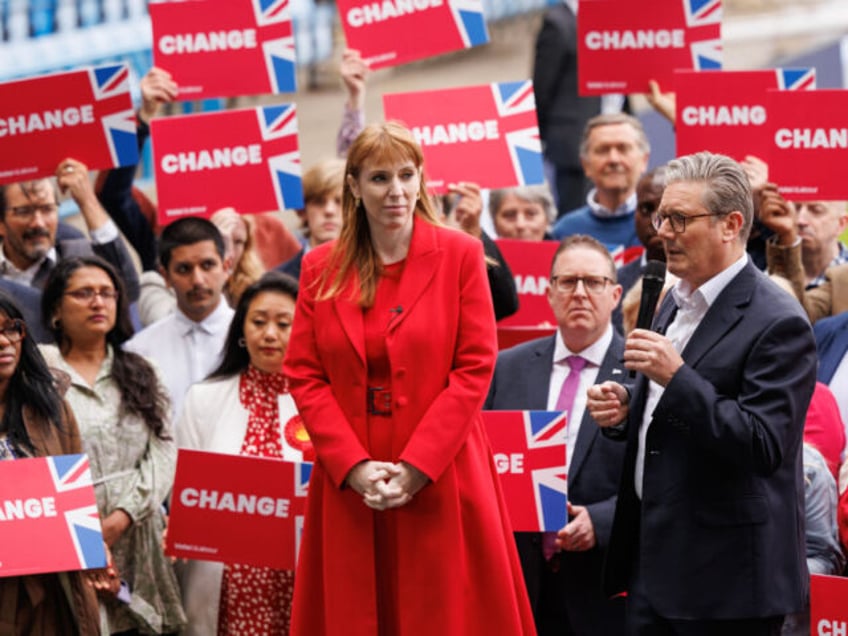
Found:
[587,153,816,636]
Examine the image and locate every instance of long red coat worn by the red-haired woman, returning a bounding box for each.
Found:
[283,218,535,636]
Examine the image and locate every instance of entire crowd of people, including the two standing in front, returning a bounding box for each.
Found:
[0,2,848,636]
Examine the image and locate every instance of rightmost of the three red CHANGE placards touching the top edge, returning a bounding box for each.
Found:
[577,0,722,95]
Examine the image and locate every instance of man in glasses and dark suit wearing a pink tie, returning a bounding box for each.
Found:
[486,235,625,636]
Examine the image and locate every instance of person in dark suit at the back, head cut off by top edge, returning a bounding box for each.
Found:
[533,0,601,216]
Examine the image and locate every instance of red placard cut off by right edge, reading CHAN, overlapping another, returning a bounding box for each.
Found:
[765,90,848,201]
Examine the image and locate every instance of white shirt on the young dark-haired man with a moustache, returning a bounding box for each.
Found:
[124,296,234,421]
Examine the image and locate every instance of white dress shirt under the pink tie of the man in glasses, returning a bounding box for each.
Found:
[548,324,612,471]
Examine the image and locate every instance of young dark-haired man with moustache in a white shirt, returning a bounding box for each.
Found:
[124,217,233,421]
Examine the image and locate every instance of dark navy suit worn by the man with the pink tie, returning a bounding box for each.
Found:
[484,331,626,636]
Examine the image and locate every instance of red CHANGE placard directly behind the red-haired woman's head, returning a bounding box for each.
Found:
[383,80,544,192]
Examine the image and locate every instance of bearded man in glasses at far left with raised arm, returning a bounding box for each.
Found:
[0,159,139,301]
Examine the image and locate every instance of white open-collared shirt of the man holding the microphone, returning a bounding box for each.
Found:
[633,252,748,499]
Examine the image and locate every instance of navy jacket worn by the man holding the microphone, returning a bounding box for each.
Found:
[605,261,816,620]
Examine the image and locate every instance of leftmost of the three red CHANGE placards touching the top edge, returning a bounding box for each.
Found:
[150,0,296,99]
